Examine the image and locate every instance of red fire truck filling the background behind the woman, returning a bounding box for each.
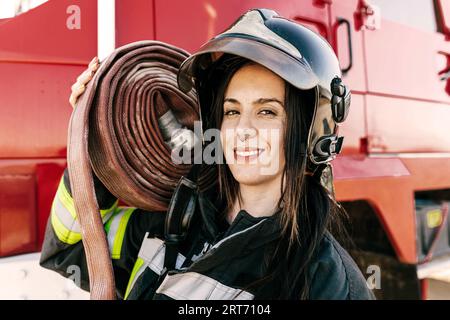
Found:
[0,0,450,299]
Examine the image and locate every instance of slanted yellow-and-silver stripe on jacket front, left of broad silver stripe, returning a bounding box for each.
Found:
[125,232,186,299]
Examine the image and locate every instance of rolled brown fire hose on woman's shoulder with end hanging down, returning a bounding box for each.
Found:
[68,41,204,299]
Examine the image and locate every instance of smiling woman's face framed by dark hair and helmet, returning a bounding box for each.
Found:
[221,64,286,185]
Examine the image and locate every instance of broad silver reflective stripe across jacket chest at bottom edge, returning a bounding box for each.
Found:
[156,272,254,300]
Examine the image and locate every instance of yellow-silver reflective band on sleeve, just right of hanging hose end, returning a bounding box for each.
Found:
[106,208,136,259]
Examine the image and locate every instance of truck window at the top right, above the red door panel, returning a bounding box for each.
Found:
[369,0,437,32]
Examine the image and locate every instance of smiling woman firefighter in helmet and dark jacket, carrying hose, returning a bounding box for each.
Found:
[41,9,374,299]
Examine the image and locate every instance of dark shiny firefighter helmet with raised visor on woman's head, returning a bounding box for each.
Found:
[178,9,350,167]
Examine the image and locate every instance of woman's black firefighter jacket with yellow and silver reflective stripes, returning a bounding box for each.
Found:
[41,170,374,300]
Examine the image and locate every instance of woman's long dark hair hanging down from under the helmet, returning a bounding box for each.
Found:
[200,54,344,299]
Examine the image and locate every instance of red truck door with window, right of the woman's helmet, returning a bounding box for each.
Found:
[333,0,450,154]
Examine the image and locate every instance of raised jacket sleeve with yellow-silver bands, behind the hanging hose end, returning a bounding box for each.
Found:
[40,169,164,298]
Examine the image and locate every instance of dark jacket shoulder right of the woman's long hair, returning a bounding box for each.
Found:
[309,232,375,300]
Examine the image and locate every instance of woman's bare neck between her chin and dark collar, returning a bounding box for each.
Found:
[227,178,281,223]
